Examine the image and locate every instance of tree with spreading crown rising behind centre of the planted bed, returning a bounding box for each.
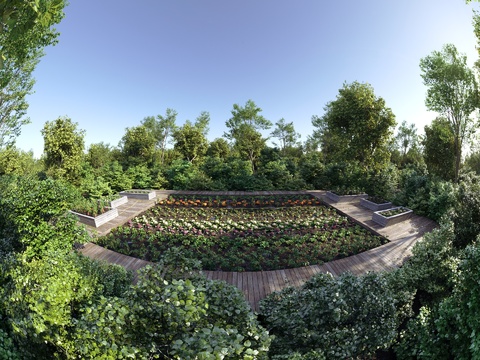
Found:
[225,100,272,169]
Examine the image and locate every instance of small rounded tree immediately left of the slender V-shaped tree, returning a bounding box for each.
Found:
[120,126,155,167]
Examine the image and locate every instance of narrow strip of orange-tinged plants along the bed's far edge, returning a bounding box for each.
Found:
[159,194,322,208]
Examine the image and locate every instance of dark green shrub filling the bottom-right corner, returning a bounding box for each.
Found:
[396,243,480,360]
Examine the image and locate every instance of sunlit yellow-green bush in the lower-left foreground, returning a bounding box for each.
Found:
[3,252,132,354]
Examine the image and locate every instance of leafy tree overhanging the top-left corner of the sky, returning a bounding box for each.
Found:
[0,0,66,147]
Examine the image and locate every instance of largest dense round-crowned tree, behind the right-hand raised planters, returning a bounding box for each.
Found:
[312,82,395,169]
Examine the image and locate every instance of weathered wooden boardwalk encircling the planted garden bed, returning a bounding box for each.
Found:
[80,190,436,311]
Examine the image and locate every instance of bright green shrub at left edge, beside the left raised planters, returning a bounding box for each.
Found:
[0,177,86,257]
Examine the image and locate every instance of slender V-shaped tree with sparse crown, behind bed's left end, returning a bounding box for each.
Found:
[142,108,178,164]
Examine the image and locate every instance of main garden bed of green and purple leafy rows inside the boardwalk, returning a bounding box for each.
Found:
[97,196,386,271]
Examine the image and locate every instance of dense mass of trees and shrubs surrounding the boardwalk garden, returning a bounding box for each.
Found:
[0,0,480,360]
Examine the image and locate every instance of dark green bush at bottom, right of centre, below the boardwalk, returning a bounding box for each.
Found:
[260,274,398,359]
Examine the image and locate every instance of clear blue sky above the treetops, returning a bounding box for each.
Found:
[17,0,478,157]
